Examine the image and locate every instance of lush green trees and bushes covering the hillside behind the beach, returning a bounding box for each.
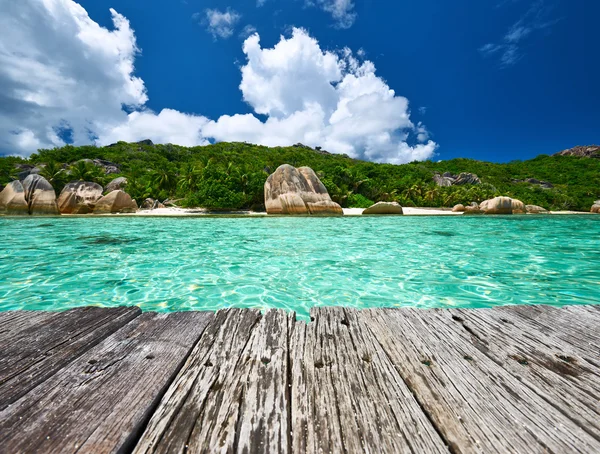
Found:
[0,142,600,211]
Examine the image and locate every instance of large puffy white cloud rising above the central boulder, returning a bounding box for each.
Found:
[202,29,437,163]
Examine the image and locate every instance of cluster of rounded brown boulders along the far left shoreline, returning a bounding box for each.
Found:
[0,173,138,215]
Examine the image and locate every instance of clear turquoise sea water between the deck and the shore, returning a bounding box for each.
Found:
[0,216,600,316]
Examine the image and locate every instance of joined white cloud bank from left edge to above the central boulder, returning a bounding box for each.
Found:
[0,0,437,163]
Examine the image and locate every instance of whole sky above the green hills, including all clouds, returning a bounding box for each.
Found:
[0,0,600,164]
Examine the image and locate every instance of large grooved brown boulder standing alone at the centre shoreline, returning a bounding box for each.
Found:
[265,164,344,215]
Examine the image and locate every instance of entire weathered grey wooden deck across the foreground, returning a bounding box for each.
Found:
[0,306,600,454]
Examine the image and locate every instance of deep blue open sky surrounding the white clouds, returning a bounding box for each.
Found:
[0,0,600,162]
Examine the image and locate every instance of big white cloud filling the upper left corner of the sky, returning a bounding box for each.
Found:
[0,0,148,154]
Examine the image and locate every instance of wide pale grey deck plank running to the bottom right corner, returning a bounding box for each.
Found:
[361,309,600,452]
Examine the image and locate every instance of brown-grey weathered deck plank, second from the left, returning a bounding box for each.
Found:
[0,312,213,453]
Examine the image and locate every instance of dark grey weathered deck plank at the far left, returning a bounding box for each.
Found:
[0,307,141,410]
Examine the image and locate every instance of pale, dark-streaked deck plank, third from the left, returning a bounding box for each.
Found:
[134,309,261,453]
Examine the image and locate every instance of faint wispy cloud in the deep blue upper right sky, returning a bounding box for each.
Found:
[479,0,558,67]
